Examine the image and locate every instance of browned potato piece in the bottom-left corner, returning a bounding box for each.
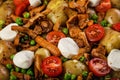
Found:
[0,64,9,80]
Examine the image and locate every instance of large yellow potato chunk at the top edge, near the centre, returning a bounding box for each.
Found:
[47,0,68,24]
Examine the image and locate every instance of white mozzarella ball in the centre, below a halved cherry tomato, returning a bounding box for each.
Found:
[58,37,79,58]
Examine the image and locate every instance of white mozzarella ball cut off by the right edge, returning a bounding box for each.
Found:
[107,49,120,71]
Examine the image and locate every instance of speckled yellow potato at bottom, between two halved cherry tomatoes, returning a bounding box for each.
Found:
[63,60,87,75]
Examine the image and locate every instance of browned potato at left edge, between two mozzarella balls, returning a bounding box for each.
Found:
[0,40,16,60]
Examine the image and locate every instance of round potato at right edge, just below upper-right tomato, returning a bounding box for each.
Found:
[105,8,120,24]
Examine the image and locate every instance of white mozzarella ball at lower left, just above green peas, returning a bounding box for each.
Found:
[13,50,34,69]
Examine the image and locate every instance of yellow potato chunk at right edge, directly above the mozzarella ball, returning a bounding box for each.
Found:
[100,28,120,53]
